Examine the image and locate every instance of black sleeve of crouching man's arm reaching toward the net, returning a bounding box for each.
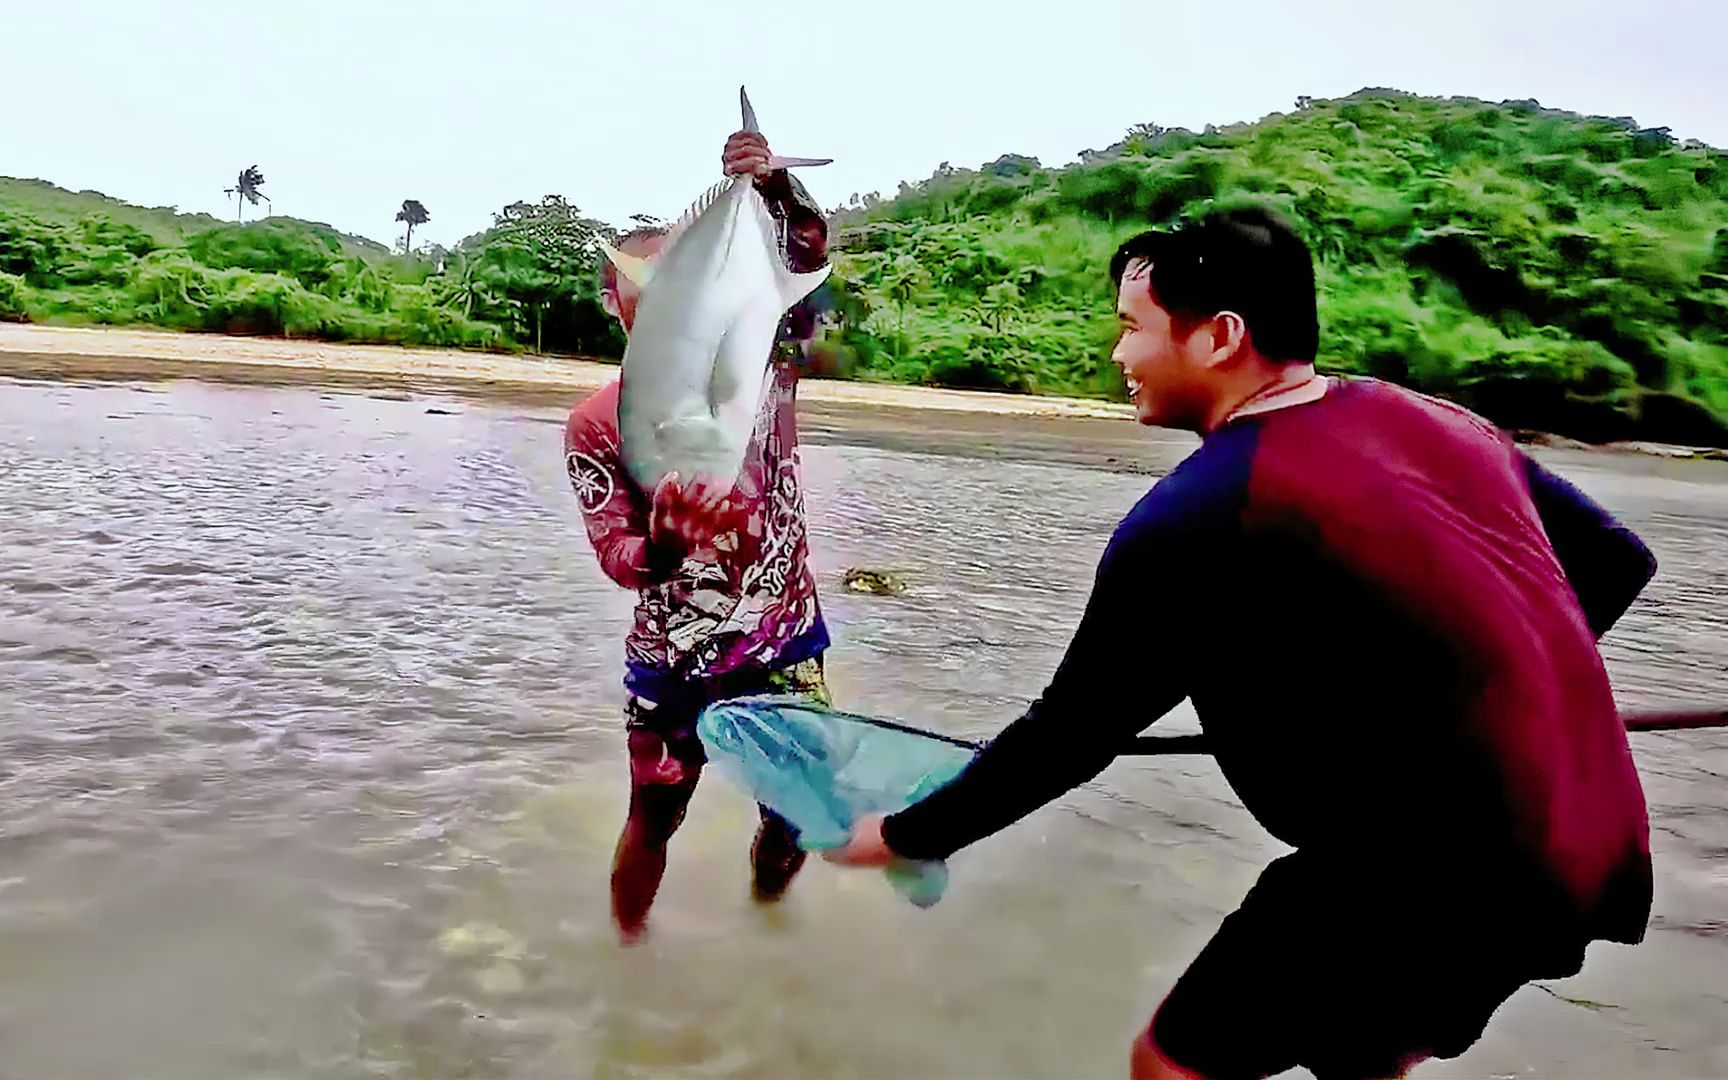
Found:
[883,518,1196,859]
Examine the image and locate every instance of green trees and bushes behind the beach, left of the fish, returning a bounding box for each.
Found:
[0,180,622,356]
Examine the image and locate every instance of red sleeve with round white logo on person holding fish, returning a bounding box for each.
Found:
[563,387,681,589]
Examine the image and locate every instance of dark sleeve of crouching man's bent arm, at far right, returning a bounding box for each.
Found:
[1519,451,1655,638]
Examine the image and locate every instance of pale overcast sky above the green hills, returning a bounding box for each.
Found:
[0,0,1728,244]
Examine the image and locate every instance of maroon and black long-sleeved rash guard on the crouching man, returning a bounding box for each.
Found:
[883,380,1655,942]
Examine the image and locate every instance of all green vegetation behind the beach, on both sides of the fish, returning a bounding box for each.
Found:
[0,90,1728,444]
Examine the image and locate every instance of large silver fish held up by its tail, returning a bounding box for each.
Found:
[601,86,831,491]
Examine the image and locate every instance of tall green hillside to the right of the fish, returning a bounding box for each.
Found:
[819,90,1728,444]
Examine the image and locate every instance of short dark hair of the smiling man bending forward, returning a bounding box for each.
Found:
[1109,206,1320,363]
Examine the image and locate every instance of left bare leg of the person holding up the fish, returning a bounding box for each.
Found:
[612,731,702,945]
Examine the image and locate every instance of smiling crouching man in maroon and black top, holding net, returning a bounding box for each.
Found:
[828,209,1655,1080]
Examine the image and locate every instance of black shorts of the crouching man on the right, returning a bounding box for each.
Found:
[1151,852,1583,1080]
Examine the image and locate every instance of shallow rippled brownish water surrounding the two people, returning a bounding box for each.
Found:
[0,373,1728,1080]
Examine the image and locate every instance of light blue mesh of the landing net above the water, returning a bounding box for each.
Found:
[696,695,978,907]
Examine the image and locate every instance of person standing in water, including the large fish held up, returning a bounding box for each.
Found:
[563,88,828,943]
